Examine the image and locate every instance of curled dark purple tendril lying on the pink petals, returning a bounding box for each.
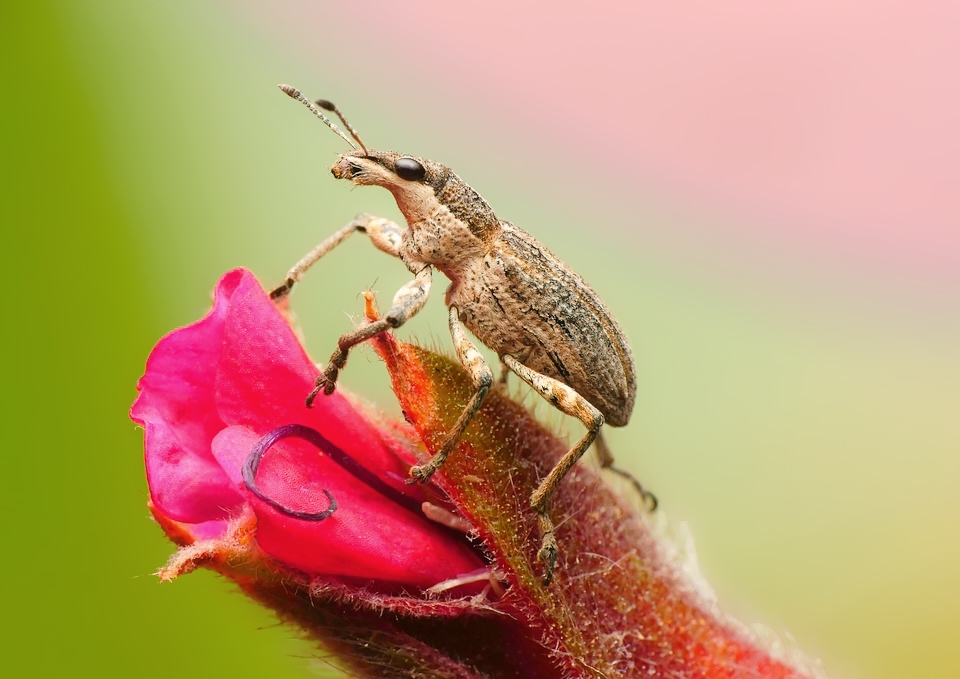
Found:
[243,424,422,521]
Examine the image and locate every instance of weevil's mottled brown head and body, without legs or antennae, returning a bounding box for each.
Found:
[332,150,637,427]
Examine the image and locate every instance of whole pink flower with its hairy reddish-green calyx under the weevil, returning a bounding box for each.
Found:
[131,270,817,679]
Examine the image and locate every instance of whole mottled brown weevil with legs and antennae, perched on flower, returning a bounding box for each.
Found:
[271,85,656,583]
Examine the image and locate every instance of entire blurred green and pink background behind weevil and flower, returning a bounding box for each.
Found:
[0,0,960,678]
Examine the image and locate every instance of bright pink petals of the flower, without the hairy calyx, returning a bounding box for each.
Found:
[131,270,485,591]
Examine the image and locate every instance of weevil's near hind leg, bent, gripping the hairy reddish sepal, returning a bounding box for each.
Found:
[500,354,603,585]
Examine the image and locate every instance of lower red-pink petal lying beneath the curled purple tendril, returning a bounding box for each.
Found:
[222,427,483,588]
